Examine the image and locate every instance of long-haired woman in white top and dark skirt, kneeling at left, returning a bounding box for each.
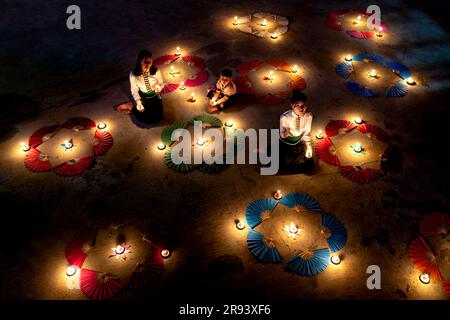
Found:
[125,50,164,123]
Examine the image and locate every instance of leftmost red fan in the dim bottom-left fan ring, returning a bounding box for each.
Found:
[64,228,96,268]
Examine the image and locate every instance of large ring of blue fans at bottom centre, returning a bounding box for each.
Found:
[245,193,347,276]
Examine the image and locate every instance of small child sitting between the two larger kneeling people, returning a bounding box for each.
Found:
[207,69,236,113]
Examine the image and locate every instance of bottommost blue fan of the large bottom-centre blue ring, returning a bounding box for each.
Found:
[287,248,330,276]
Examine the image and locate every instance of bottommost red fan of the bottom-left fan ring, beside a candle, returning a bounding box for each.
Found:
[80,269,123,300]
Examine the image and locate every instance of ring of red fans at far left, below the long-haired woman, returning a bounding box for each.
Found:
[24,117,113,176]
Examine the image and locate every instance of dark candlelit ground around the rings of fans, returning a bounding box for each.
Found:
[0,0,450,301]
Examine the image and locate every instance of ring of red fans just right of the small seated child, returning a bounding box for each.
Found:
[236,60,306,105]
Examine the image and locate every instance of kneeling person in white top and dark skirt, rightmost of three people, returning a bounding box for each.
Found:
[280,89,313,170]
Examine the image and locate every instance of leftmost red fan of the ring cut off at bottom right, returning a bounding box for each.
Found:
[408,237,442,281]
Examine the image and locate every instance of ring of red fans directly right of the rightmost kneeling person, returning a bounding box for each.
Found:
[315,120,390,183]
